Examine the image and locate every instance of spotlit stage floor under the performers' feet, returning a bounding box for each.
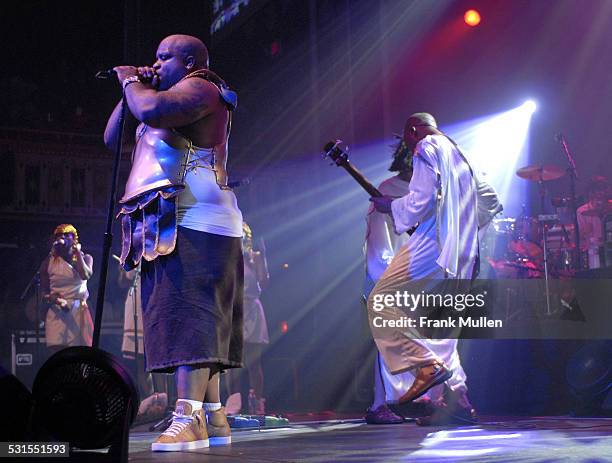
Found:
[129,417,612,463]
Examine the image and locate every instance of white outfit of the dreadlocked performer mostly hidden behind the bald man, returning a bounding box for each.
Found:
[365,176,466,403]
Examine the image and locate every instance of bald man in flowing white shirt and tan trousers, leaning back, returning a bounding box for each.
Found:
[368,113,502,426]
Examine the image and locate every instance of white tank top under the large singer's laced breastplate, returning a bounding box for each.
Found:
[177,146,242,238]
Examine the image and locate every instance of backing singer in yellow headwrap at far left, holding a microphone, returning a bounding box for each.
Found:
[40,224,93,353]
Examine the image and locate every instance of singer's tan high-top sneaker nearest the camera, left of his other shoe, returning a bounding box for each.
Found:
[151,400,209,452]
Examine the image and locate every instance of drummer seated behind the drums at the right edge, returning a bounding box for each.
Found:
[577,178,612,251]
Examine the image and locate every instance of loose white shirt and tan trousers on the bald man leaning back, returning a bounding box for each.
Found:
[368,135,501,392]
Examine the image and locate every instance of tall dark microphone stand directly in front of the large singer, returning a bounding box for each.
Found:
[92,88,127,348]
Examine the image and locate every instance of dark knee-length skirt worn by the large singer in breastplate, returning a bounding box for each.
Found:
[142,227,244,372]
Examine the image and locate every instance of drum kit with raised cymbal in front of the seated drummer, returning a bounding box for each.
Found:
[482,165,612,279]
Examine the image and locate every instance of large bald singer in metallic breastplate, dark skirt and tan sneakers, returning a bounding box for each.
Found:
[104,35,244,451]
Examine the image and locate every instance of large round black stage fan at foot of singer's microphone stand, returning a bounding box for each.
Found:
[32,347,139,461]
